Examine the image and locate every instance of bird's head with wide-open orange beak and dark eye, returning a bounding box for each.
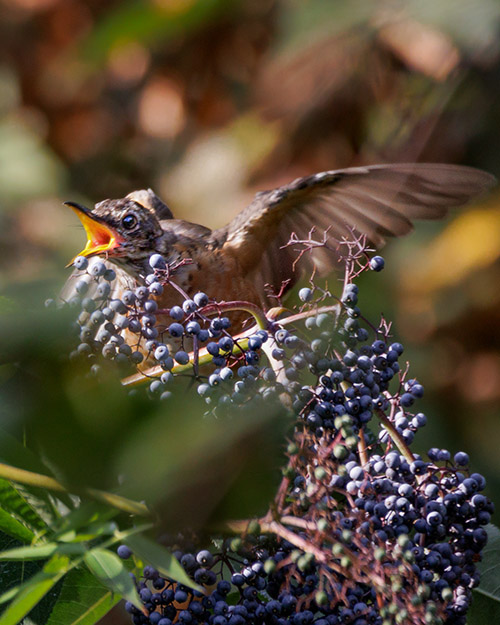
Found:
[65,189,172,263]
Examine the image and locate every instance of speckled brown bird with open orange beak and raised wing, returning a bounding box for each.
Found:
[63,163,496,322]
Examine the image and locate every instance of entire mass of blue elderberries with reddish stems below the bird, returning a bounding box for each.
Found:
[61,240,493,625]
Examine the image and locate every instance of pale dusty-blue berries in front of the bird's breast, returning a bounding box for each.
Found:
[59,254,245,386]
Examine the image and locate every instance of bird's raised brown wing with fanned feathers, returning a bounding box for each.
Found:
[212,163,496,298]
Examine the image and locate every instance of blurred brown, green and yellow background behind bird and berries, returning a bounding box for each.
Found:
[0,0,500,616]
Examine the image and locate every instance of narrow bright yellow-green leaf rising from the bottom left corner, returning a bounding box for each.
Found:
[0,556,70,625]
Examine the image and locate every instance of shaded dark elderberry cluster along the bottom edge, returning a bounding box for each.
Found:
[118,536,398,625]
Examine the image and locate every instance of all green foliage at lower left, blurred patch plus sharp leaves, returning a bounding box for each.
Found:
[0,302,291,625]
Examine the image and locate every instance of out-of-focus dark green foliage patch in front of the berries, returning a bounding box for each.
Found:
[0,310,291,532]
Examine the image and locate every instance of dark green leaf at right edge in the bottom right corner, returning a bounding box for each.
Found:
[467,525,500,625]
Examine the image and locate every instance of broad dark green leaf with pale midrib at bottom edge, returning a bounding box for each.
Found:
[45,569,120,625]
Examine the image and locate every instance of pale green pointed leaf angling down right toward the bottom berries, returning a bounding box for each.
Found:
[82,548,143,608]
